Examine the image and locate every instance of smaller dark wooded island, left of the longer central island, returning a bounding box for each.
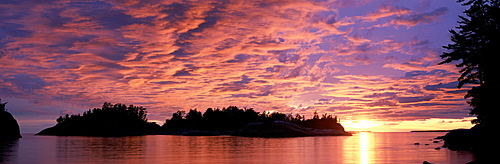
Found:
[36,102,160,136]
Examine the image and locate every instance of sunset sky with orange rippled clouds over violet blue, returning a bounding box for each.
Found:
[0,0,471,132]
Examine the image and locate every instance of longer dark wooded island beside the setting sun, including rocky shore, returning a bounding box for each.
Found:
[160,106,351,137]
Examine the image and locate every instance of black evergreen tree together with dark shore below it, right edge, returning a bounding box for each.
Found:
[440,0,500,163]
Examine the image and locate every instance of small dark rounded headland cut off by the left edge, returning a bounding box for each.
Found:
[0,102,22,140]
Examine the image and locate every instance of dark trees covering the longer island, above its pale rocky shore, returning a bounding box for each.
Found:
[162,106,344,131]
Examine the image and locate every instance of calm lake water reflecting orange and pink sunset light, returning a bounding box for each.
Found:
[0,132,474,164]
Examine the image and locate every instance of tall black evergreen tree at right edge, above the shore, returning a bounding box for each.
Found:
[439,0,500,128]
